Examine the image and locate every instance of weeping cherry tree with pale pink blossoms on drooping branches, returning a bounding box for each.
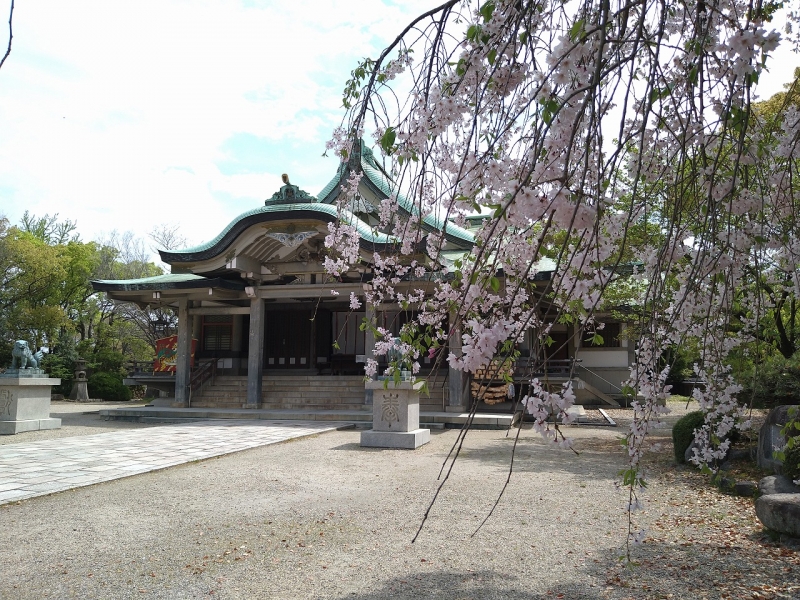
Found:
[328,0,800,552]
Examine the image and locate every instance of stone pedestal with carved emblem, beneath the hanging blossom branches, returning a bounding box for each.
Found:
[361,381,431,450]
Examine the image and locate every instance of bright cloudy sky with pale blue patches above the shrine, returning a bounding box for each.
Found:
[0,0,800,253]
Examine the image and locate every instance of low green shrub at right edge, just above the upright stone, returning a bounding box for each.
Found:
[740,355,800,407]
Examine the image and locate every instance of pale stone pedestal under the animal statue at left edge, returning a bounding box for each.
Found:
[0,369,61,435]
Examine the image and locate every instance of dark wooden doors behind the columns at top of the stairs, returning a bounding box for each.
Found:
[264,310,313,369]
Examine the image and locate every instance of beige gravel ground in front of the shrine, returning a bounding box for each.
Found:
[0,405,800,600]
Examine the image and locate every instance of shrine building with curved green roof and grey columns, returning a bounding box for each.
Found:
[92,142,633,412]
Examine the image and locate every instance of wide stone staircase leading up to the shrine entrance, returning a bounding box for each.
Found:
[191,374,443,412]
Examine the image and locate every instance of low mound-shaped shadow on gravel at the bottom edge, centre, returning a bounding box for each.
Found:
[332,571,598,600]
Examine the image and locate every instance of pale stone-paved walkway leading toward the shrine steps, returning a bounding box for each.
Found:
[0,420,352,504]
